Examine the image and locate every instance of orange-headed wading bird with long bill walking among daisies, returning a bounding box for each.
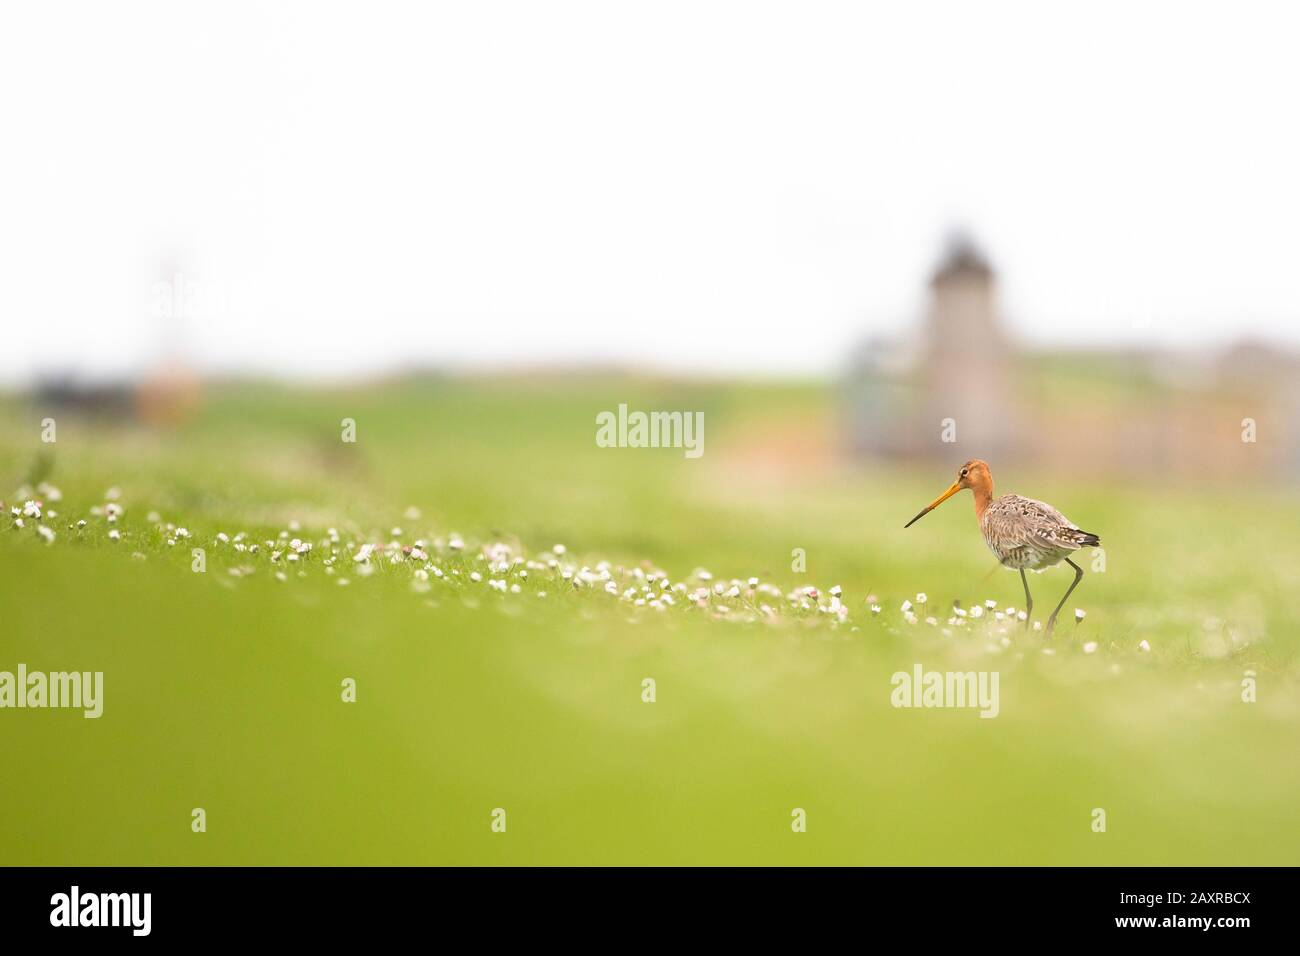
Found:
[904,458,1101,633]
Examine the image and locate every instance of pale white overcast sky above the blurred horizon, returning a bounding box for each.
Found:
[0,0,1300,382]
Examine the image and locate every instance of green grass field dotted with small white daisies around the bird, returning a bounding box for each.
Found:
[0,376,1300,865]
